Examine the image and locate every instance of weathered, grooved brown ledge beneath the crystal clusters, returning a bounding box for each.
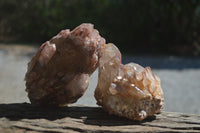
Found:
[0,103,200,133]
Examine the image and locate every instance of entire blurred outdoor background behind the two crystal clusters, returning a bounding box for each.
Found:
[0,0,200,114]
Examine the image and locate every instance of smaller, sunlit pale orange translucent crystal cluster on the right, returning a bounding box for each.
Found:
[95,44,164,121]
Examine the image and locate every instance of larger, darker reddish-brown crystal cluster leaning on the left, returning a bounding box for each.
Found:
[25,24,105,106]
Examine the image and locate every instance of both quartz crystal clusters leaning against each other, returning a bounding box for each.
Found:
[25,24,164,120]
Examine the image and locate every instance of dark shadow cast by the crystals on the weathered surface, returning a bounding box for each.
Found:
[0,103,156,126]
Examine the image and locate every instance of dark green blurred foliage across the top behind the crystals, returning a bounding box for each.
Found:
[0,0,200,56]
